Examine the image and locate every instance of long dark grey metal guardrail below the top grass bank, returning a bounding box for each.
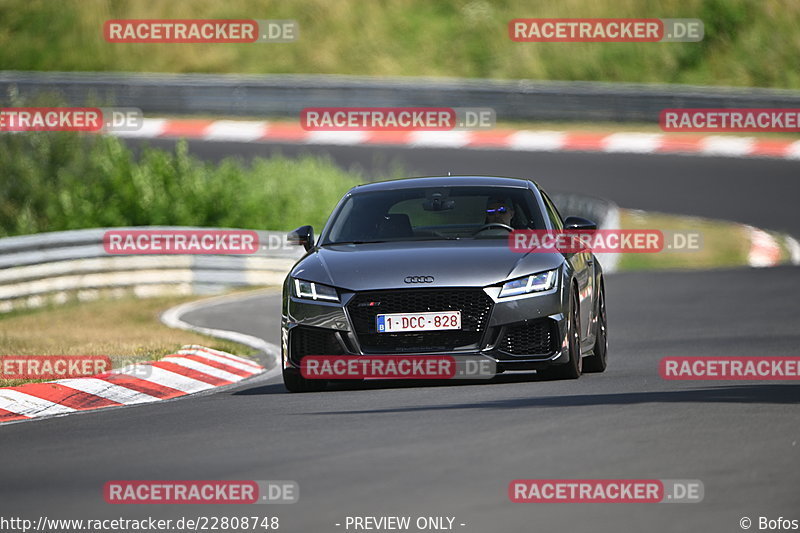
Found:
[0,71,800,122]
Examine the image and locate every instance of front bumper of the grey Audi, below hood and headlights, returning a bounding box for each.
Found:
[281,279,569,373]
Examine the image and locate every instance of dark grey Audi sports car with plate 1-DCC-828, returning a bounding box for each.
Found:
[282,176,607,392]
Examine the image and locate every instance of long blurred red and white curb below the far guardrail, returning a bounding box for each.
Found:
[114,118,800,159]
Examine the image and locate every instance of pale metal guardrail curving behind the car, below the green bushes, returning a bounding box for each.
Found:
[0,194,617,313]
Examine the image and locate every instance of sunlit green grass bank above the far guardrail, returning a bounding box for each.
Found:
[0,0,800,88]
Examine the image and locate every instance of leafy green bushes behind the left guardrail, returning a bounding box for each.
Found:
[0,133,359,236]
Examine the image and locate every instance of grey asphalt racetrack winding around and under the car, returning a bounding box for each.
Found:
[0,141,800,533]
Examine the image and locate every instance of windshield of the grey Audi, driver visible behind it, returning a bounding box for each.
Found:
[322,187,545,246]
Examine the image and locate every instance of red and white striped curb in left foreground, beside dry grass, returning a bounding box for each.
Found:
[0,345,265,423]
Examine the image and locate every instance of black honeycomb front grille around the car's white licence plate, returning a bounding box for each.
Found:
[347,289,492,353]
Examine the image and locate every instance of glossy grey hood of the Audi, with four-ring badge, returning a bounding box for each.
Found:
[291,239,564,291]
